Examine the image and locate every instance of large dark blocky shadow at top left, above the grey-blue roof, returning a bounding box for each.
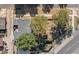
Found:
[15,4,38,17]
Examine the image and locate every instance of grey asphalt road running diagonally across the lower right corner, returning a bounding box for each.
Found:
[57,31,79,54]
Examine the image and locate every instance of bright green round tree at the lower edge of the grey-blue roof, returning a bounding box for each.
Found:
[16,33,37,50]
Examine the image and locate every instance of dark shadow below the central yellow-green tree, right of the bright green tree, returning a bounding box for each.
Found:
[32,34,47,53]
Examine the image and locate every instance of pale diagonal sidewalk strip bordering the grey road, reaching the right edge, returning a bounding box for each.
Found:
[48,30,79,54]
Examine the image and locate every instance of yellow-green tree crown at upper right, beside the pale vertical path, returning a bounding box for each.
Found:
[57,9,69,26]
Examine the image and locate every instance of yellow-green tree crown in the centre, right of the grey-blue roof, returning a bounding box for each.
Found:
[31,16,47,35]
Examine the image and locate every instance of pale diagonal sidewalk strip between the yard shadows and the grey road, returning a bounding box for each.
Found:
[41,35,73,54]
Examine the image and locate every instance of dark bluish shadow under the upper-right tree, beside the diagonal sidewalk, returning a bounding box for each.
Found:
[52,26,72,45]
